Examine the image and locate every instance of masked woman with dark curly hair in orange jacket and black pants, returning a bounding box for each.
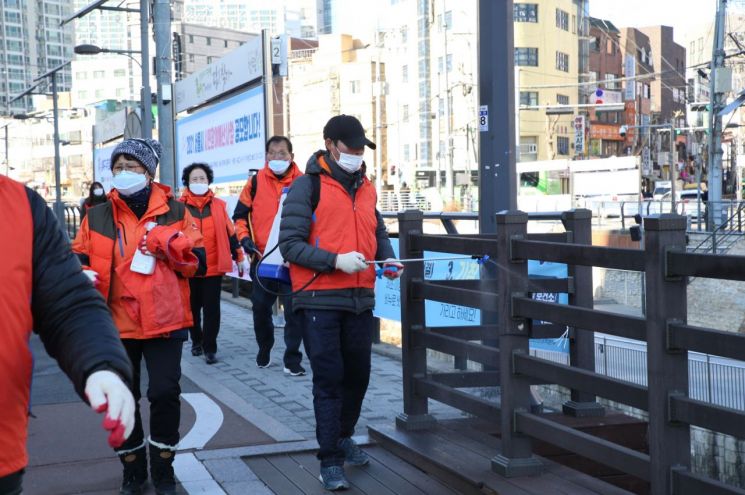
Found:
[181,163,249,364]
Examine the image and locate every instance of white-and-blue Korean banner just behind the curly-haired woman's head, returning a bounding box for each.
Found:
[176,86,266,183]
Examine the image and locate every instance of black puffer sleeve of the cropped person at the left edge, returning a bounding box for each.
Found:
[26,188,132,400]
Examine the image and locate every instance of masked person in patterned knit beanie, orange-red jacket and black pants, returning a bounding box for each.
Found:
[73,139,206,494]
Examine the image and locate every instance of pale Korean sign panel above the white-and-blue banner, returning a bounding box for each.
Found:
[176,36,264,112]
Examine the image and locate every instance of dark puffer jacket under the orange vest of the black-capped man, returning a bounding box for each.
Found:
[279,151,394,314]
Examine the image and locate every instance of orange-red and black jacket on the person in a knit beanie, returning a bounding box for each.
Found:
[72,182,202,339]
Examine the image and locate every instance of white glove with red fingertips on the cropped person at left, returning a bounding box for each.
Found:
[85,370,135,448]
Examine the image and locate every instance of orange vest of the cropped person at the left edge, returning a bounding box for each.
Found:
[0,176,34,477]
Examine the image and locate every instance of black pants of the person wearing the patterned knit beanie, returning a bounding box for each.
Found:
[117,337,184,450]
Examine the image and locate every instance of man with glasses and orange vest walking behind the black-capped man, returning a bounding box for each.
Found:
[233,136,305,376]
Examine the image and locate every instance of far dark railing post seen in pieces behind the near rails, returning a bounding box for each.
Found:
[561,209,605,417]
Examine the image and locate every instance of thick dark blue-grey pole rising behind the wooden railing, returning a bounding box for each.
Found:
[478,0,517,234]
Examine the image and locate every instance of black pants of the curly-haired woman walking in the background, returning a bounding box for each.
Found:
[189,275,222,353]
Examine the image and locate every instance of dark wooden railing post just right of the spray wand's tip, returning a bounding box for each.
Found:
[491,211,543,477]
